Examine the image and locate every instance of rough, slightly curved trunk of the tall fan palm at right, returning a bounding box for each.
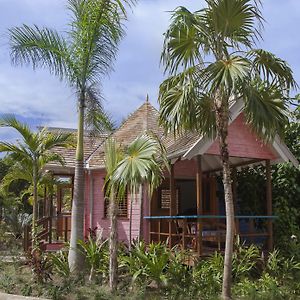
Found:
[215,101,234,300]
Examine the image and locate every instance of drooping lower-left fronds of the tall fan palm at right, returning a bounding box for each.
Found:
[159,67,215,136]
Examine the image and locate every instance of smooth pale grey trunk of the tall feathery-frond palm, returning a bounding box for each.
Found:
[68,97,84,273]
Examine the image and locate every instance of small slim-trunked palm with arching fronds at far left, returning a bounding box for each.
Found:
[0,116,73,249]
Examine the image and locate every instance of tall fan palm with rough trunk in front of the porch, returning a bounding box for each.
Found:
[159,0,296,299]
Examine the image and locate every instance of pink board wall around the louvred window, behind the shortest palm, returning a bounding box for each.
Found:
[85,170,148,242]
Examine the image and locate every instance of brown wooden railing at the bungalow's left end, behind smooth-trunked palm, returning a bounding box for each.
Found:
[23,213,71,251]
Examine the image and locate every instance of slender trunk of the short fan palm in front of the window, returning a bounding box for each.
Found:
[109,191,118,291]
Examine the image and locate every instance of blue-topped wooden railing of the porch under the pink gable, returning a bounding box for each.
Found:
[144,215,276,255]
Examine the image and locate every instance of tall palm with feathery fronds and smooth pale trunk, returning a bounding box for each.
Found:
[9,0,135,271]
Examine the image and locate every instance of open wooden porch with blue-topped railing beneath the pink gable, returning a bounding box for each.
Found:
[144,155,276,256]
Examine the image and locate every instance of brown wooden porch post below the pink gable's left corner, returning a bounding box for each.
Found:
[196,155,203,256]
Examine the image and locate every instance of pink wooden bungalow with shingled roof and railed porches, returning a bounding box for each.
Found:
[25,101,298,255]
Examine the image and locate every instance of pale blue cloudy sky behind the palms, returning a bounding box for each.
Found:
[0,0,300,141]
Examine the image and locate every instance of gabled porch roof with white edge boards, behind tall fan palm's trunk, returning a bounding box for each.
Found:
[168,99,299,171]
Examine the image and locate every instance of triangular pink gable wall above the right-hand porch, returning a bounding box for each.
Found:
[206,113,277,160]
